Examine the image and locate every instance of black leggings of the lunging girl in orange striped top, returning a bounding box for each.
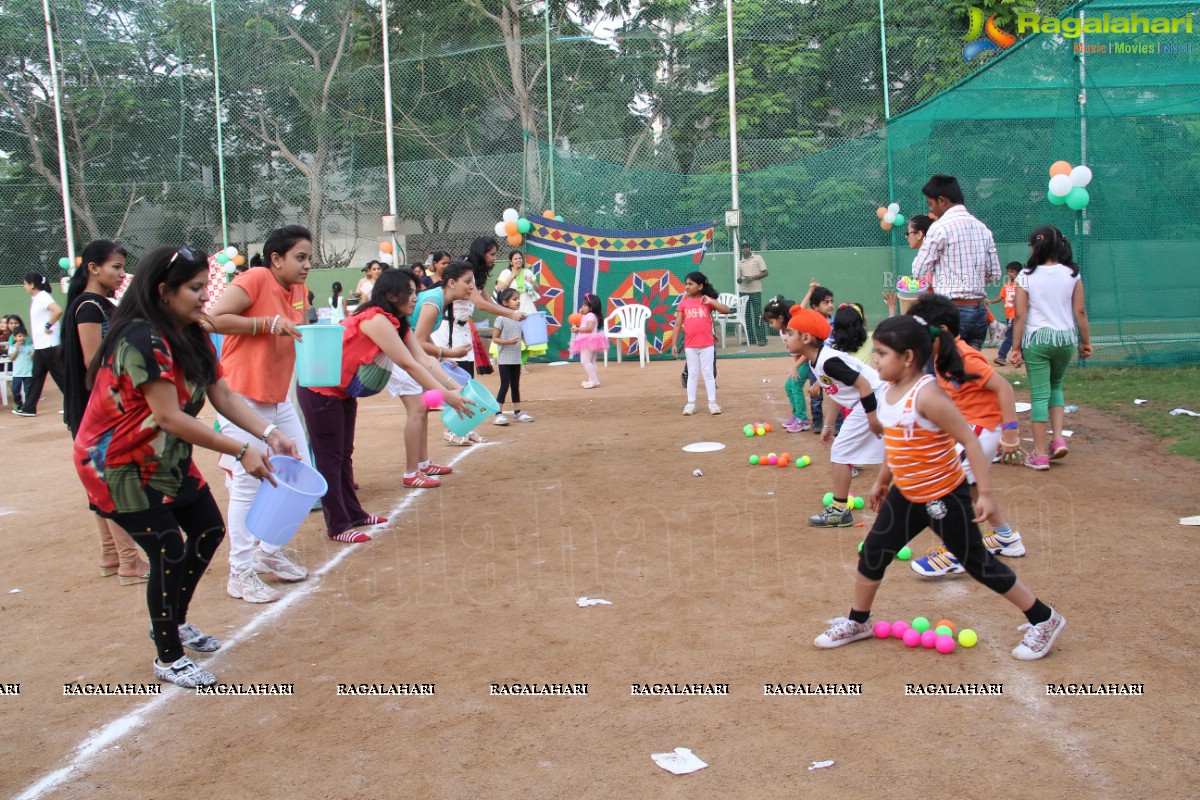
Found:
[858,481,1016,595]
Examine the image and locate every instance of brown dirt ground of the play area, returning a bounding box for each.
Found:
[0,352,1200,800]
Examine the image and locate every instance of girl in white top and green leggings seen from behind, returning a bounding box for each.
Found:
[1008,225,1092,470]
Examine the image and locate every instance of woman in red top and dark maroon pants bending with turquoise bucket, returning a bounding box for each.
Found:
[296,270,472,545]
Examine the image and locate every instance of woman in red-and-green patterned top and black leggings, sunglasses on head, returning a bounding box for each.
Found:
[74,247,299,688]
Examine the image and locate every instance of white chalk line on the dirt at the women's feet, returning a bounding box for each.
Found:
[14,441,497,800]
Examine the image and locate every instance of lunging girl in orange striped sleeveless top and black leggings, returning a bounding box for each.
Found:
[814,317,1067,661]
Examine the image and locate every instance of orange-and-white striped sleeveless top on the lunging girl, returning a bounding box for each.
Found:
[876,375,966,503]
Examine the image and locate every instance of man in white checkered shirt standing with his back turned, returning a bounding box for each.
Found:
[912,175,1000,350]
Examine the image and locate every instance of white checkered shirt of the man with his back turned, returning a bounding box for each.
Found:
[912,204,1000,300]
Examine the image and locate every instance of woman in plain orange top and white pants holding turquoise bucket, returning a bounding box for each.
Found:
[212,225,312,603]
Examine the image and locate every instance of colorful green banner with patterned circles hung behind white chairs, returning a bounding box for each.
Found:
[526,216,713,360]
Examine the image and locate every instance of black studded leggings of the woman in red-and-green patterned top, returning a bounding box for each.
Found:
[113,487,226,664]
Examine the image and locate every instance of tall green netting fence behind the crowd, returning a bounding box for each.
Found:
[0,0,1200,363]
